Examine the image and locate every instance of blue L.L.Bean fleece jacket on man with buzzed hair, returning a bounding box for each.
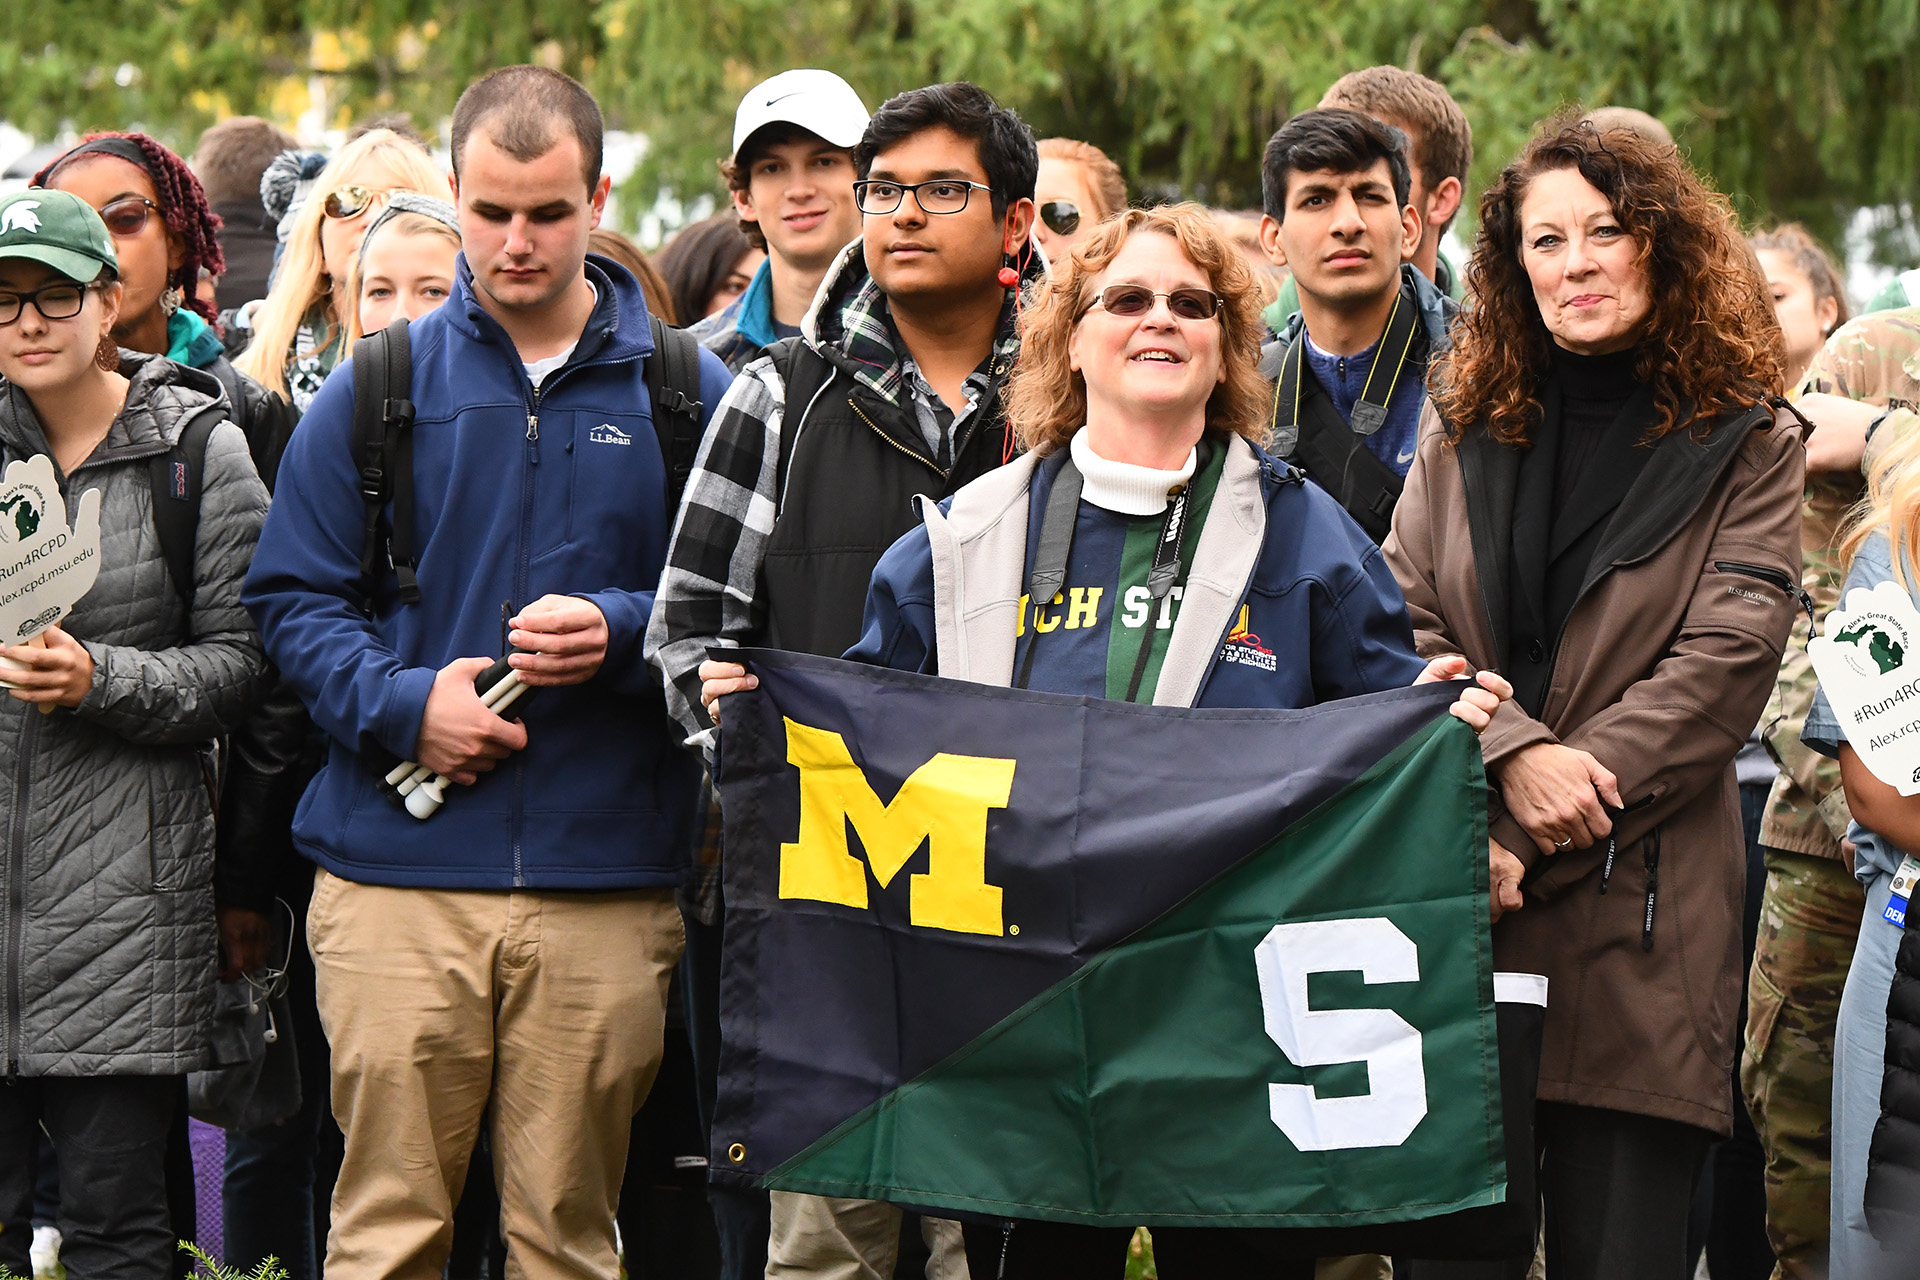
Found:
[244,255,730,890]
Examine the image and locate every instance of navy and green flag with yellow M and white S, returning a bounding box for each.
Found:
[712,651,1538,1247]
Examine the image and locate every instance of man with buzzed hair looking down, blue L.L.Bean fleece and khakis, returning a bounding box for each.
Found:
[246,67,728,1280]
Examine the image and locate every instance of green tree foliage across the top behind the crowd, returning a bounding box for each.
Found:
[0,0,1920,253]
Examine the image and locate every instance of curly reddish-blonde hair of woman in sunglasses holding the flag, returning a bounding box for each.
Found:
[1006,201,1273,457]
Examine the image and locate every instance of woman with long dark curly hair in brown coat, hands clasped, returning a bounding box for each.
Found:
[1386,123,1803,1280]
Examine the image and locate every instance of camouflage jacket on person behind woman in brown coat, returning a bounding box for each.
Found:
[1761,307,1920,858]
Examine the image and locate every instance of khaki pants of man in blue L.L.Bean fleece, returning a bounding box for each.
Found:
[307,871,685,1280]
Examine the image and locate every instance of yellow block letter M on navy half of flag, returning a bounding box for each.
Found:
[780,718,1014,936]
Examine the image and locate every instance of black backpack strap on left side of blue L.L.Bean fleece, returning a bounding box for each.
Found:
[351,317,420,616]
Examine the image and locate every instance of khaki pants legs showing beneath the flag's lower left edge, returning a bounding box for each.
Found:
[766,1192,975,1280]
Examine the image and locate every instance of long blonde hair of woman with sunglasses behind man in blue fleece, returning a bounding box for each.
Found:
[234,129,447,399]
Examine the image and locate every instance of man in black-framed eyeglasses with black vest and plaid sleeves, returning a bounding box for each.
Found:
[647,83,1041,1280]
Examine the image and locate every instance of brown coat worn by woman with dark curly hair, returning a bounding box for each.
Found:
[1384,405,1805,1134]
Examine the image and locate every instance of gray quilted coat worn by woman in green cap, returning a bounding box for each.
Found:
[0,351,267,1077]
